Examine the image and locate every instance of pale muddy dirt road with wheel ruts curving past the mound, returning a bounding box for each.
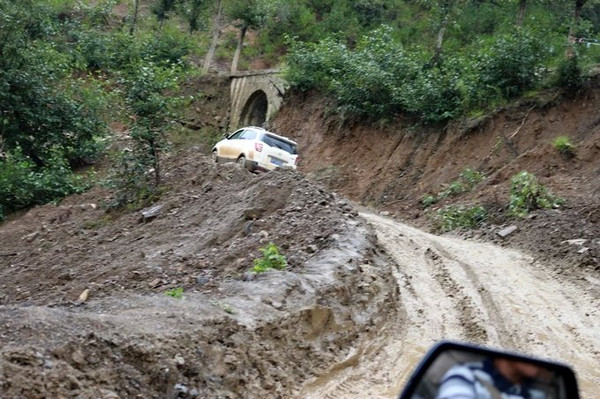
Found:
[301,213,600,399]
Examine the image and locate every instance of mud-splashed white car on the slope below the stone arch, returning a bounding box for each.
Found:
[212,126,298,172]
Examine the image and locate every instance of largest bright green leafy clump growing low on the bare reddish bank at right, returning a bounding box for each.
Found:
[508,171,564,217]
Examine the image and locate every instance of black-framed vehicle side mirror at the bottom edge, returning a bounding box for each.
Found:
[399,342,579,399]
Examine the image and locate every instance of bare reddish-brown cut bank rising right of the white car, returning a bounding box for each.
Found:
[273,79,600,275]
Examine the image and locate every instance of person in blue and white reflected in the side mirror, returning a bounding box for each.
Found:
[436,358,546,399]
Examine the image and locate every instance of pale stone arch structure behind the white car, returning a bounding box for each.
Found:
[229,69,286,130]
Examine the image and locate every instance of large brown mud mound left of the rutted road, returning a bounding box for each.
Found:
[0,149,398,398]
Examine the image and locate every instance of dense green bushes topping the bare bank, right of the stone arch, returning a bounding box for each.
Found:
[286,19,551,122]
